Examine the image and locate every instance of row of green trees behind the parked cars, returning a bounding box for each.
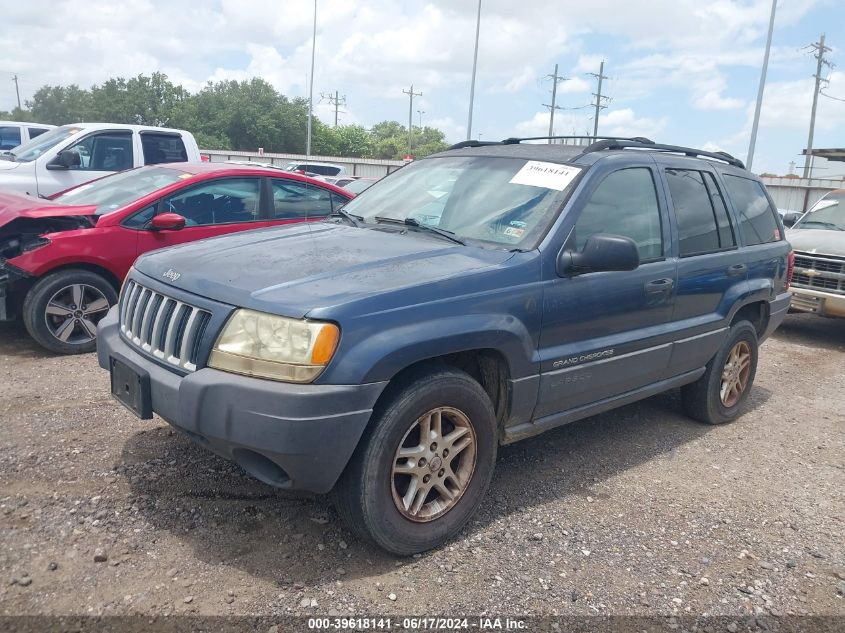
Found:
[18,72,454,159]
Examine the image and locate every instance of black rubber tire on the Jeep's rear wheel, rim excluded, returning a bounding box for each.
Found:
[681,321,759,424]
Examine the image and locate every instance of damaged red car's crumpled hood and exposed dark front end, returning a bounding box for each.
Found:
[0,192,97,259]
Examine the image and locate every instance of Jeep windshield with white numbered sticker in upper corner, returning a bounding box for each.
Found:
[344,156,581,250]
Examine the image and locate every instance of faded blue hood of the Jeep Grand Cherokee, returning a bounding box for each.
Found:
[135,222,513,318]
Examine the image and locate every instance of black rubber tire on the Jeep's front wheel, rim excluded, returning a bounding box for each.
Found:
[333,367,497,556]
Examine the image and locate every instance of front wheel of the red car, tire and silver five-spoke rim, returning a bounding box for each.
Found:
[23,269,117,354]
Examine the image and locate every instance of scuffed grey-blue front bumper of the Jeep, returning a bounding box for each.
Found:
[97,308,387,493]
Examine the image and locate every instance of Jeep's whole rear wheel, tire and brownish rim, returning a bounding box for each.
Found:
[681,321,758,424]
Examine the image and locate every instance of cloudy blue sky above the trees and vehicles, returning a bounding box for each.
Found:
[0,0,845,177]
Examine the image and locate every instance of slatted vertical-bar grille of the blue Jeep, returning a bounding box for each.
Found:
[120,280,211,371]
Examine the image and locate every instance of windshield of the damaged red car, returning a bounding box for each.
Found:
[55,167,191,215]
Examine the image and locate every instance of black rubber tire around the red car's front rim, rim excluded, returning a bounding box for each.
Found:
[22,269,117,354]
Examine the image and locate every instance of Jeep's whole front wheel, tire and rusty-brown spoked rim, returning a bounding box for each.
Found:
[334,369,497,556]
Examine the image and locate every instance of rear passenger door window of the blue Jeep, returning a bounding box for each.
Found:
[666,169,734,257]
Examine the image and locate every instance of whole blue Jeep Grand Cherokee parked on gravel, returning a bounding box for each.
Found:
[97,139,791,554]
